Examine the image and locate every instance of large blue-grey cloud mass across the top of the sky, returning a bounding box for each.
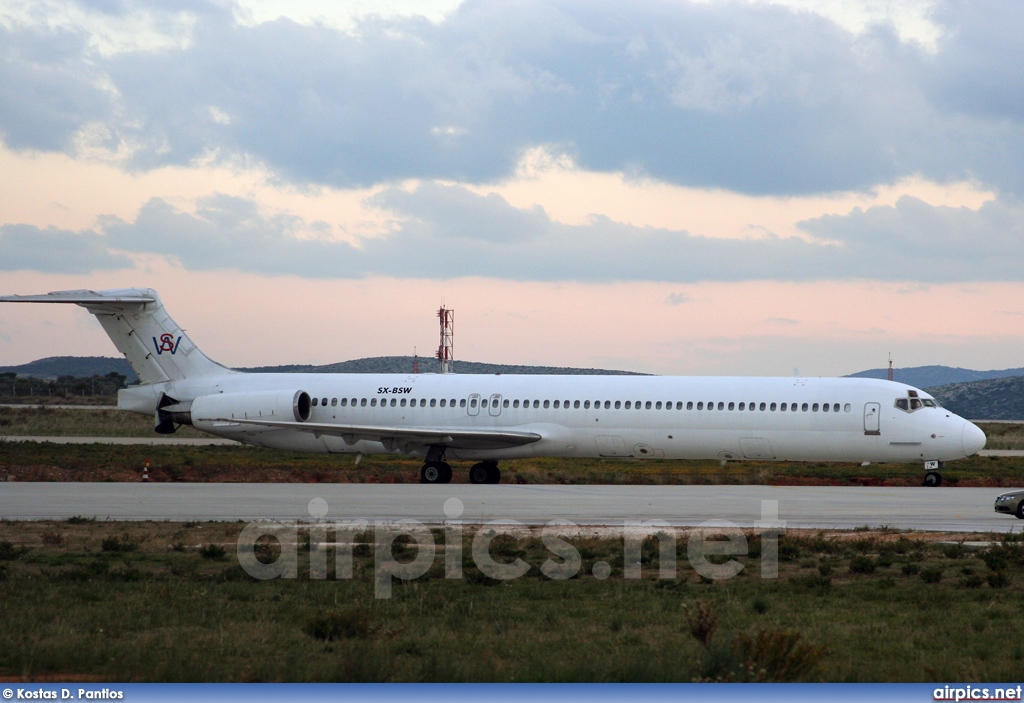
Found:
[6,0,1024,194]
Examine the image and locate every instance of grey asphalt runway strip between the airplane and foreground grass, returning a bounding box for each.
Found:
[0,482,1024,532]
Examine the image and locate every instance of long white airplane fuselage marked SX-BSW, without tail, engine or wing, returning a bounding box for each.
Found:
[128,372,985,463]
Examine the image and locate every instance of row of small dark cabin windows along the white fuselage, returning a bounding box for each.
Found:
[312,398,852,412]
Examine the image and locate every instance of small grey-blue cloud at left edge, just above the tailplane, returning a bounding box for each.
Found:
[0,224,132,273]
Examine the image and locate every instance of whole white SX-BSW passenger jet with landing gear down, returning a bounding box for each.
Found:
[0,288,986,486]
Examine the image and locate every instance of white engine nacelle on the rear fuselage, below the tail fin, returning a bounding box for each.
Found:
[188,391,311,430]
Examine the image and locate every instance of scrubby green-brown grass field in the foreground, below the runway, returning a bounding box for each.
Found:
[0,519,1024,683]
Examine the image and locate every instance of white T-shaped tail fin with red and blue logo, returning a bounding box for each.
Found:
[0,288,230,384]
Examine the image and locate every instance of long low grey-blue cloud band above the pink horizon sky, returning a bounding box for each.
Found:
[6,182,1024,284]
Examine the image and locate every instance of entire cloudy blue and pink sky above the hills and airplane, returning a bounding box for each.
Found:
[0,0,1024,376]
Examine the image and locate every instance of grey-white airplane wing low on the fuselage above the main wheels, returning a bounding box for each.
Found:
[213,418,543,450]
